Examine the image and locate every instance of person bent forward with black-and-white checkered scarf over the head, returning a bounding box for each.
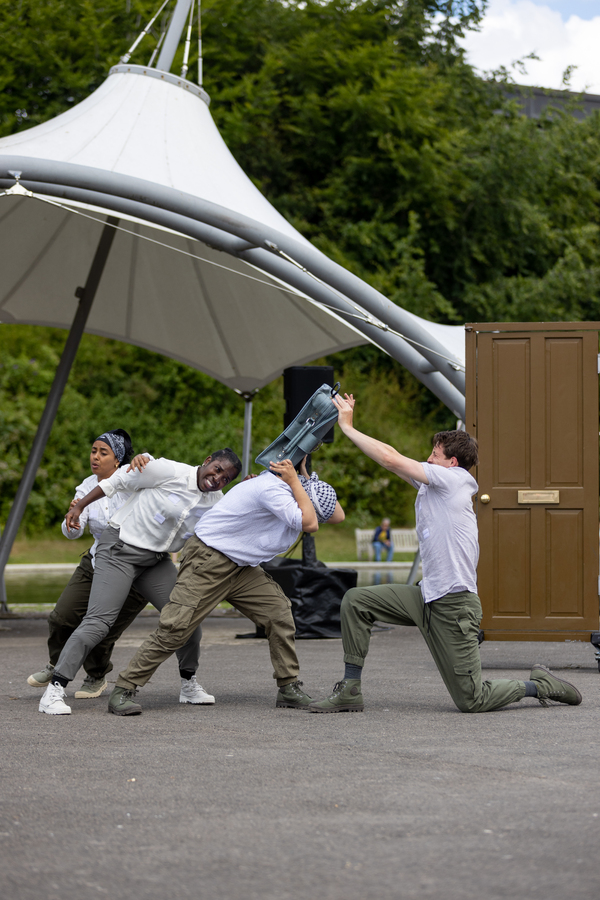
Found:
[108,460,344,716]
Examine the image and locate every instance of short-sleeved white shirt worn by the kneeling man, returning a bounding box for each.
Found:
[411,463,479,603]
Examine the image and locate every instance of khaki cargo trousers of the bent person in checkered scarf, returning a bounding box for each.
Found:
[117,535,300,690]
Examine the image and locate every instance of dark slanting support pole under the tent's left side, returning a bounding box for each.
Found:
[0,216,119,612]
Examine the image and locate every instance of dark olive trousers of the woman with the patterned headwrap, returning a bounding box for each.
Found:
[48,551,147,679]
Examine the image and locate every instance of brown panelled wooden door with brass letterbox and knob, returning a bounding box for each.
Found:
[467,323,600,641]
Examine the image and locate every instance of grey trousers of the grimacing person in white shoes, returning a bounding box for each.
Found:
[54,526,202,681]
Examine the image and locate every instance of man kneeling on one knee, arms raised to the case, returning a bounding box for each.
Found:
[309,394,581,713]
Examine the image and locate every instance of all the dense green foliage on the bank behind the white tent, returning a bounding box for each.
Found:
[0,0,600,529]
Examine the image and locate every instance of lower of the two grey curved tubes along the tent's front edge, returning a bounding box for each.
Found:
[0,179,465,419]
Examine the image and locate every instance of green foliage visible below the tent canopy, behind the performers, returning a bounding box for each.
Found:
[0,325,443,533]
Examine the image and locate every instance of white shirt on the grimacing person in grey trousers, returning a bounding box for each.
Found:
[99,458,223,553]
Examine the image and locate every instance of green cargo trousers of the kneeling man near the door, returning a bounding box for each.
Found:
[341,584,525,712]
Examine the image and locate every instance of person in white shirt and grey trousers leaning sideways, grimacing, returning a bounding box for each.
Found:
[39,448,242,715]
